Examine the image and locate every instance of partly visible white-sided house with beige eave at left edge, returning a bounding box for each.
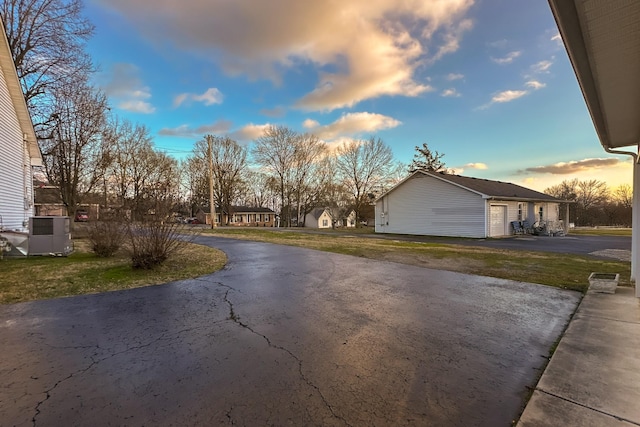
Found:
[0,22,42,232]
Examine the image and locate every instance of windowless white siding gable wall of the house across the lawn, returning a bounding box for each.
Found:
[375,175,486,238]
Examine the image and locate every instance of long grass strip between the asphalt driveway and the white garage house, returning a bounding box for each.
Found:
[203,227,631,292]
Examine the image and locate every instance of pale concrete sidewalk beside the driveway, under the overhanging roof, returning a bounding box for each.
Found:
[518,287,640,427]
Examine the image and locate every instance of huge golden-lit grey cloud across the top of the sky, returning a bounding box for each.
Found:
[96,0,475,111]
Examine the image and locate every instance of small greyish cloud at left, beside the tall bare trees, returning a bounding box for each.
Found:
[98,63,156,114]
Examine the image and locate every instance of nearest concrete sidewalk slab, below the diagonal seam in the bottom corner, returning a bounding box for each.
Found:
[518,390,634,427]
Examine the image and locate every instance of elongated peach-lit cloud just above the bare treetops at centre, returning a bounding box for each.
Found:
[307,112,402,140]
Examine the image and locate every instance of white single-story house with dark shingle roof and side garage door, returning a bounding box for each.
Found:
[375,171,568,238]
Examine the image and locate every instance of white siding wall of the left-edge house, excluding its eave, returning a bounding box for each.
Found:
[0,65,33,231]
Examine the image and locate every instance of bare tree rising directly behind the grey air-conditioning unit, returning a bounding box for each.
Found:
[41,84,107,214]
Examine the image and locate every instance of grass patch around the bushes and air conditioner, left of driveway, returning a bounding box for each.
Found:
[0,240,226,304]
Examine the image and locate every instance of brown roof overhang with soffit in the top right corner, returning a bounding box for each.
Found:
[549,0,640,148]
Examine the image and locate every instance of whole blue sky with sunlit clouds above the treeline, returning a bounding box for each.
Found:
[84,0,632,191]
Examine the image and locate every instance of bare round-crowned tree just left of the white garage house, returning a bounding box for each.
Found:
[336,137,393,225]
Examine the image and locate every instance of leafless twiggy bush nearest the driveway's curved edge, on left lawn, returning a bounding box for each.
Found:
[129,221,189,270]
